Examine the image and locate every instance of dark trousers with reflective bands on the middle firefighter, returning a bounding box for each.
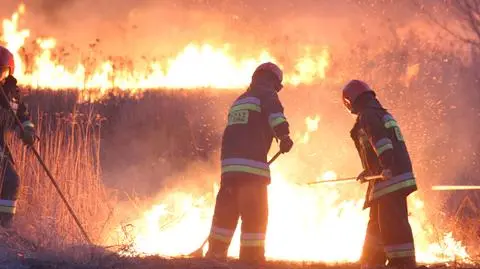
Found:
[206,182,268,263]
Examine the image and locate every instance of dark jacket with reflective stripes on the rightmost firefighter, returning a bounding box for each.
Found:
[351,100,417,208]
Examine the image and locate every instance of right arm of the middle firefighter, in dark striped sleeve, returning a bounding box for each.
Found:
[262,92,293,152]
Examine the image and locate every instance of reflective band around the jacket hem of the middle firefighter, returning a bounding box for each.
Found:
[222,158,270,177]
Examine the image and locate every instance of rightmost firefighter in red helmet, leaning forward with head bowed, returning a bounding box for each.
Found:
[343,80,417,268]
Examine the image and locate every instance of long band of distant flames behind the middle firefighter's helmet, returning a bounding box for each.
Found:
[1,4,329,102]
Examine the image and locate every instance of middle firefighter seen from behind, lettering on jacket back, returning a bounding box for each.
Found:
[206,62,293,263]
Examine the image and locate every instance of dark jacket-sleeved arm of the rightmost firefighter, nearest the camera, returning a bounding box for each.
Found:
[362,113,394,170]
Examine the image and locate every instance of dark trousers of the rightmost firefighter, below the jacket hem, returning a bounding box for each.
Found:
[360,194,416,268]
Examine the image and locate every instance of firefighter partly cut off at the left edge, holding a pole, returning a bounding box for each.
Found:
[0,46,36,228]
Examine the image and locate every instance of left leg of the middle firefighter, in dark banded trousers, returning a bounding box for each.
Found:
[206,184,240,259]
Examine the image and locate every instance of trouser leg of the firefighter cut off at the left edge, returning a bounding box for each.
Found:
[0,161,20,228]
